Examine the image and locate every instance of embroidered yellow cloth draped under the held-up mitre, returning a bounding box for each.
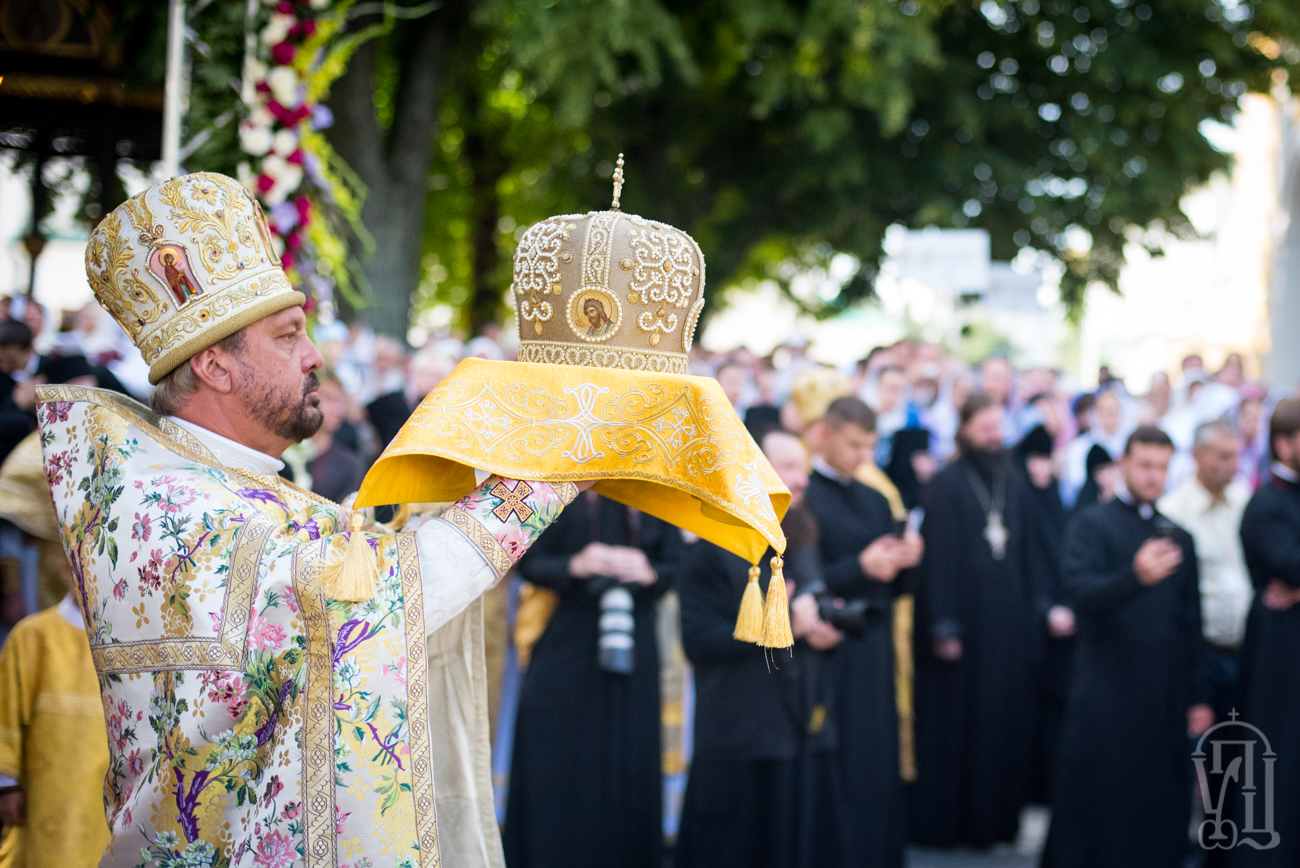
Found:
[356,359,790,563]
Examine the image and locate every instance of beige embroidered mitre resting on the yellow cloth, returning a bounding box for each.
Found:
[511,168,705,374]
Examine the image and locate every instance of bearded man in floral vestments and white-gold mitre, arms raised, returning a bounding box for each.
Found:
[39,174,579,868]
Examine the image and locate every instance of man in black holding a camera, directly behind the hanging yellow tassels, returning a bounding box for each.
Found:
[675,431,841,868]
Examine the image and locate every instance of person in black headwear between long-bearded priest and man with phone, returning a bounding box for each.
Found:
[1015,425,1076,804]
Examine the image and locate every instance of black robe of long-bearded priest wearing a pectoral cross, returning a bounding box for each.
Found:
[907,457,1039,847]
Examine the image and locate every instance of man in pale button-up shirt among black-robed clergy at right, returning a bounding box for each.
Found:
[1160,420,1255,720]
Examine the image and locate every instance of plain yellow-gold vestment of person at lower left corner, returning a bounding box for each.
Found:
[0,599,109,868]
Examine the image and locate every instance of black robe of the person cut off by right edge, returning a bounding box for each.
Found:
[1230,473,1300,868]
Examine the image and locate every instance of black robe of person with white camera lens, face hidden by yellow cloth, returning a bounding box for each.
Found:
[503,492,684,868]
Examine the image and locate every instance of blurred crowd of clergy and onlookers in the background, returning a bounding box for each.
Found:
[0,300,1300,868]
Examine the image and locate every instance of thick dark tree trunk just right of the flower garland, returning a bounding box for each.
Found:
[329,3,464,342]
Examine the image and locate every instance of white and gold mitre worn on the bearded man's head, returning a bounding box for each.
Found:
[86,172,306,383]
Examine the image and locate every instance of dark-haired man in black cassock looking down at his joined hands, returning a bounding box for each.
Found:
[806,398,922,868]
